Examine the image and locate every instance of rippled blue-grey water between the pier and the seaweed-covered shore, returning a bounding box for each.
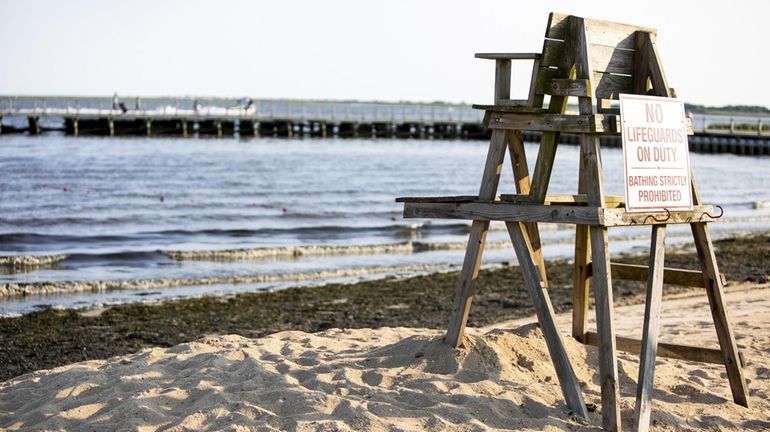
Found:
[0,135,770,315]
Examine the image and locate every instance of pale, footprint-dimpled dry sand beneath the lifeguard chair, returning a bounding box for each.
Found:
[0,284,770,431]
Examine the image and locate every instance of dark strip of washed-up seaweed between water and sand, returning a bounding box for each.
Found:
[0,233,770,381]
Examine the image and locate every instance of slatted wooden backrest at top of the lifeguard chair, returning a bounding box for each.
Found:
[530,13,657,106]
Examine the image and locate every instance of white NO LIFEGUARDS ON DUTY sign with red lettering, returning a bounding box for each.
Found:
[620,94,692,212]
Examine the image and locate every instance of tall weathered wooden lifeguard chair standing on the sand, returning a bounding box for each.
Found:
[396,13,748,430]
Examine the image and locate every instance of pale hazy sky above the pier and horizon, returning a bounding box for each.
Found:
[0,0,770,106]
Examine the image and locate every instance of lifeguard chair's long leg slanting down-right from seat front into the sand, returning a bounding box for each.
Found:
[505,222,588,419]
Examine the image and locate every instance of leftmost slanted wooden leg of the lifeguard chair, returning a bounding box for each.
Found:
[444,130,507,348]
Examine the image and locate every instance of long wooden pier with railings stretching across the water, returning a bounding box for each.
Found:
[0,96,770,155]
